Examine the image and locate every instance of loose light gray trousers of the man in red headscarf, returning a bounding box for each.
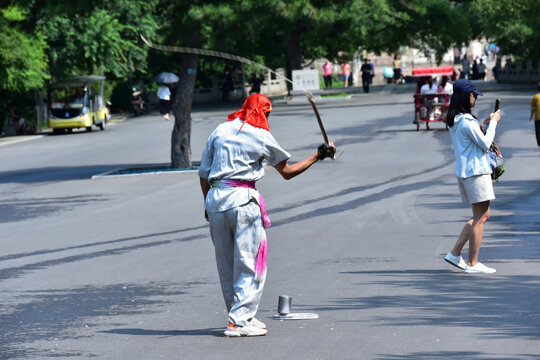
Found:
[208,200,265,326]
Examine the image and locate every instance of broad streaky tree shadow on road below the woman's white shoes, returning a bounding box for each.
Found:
[312,270,540,344]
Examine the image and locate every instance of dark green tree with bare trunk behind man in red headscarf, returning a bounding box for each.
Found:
[150,0,414,167]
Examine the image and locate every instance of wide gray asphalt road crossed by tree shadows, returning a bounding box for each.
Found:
[0,88,540,360]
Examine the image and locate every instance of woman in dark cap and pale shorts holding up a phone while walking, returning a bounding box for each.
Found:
[444,79,501,274]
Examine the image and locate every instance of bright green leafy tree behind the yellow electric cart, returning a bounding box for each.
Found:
[32,0,157,79]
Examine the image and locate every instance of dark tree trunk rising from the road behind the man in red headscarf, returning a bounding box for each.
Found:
[171,54,198,168]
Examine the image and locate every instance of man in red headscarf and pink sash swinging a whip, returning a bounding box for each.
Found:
[199,94,335,337]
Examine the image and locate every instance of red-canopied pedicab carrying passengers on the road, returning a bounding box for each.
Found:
[412,65,454,131]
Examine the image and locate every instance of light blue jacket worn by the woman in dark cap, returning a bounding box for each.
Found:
[450,114,497,179]
